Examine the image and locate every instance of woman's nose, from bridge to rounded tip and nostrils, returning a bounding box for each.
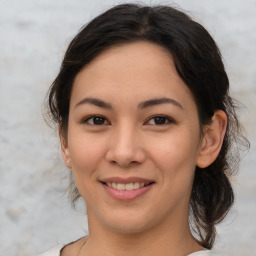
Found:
[106,124,146,168]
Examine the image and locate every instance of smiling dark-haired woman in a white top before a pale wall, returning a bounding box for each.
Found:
[41,4,247,256]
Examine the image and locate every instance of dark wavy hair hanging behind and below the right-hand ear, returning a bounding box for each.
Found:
[190,96,246,248]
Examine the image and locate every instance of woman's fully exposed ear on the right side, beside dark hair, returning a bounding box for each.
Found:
[196,110,227,168]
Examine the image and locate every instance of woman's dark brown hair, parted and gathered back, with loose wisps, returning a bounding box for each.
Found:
[48,4,248,249]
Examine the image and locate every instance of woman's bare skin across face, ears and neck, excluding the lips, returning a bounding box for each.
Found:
[61,42,226,256]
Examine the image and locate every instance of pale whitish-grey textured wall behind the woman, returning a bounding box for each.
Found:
[0,0,256,256]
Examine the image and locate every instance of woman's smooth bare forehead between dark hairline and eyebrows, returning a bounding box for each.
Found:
[71,41,195,110]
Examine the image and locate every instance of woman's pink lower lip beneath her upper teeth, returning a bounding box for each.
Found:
[102,183,154,201]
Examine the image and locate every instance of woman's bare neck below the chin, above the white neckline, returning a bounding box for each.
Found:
[80,211,203,256]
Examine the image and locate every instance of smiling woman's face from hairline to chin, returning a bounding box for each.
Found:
[62,42,204,232]
